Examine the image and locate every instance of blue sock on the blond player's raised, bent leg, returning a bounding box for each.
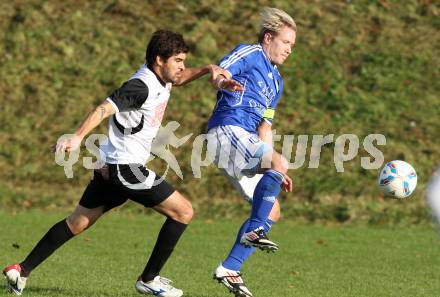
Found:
[246,169,284,232]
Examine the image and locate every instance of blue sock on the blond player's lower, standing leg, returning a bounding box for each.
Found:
[223,219,275,271]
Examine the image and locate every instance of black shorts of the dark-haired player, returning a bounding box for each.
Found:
[79,164,175,211]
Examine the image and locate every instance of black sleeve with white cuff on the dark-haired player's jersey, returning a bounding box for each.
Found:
[107,79,148,112]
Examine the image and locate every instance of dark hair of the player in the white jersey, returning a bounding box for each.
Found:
[145,30,189,67]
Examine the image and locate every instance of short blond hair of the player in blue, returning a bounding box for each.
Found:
[258,7,296,43]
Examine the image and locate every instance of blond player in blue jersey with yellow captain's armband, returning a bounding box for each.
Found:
[207,8,296,297]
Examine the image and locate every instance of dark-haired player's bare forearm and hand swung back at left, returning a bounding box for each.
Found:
[52,101,116,151]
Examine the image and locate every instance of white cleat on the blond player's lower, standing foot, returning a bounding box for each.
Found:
[213,264,252,297]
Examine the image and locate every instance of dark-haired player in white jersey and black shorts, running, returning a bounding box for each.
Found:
[3,30,241,297]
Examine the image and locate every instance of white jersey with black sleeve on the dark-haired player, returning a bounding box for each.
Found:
[100,65,172,164]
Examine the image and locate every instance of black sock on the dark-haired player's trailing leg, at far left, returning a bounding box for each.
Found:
[20,219,74,277]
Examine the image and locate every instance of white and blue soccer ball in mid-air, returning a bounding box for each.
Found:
[378,160,417,198]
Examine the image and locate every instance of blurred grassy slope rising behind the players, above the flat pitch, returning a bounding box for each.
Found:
[0,0,440,224]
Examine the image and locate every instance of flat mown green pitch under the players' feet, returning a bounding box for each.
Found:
[0,211,440,297]
